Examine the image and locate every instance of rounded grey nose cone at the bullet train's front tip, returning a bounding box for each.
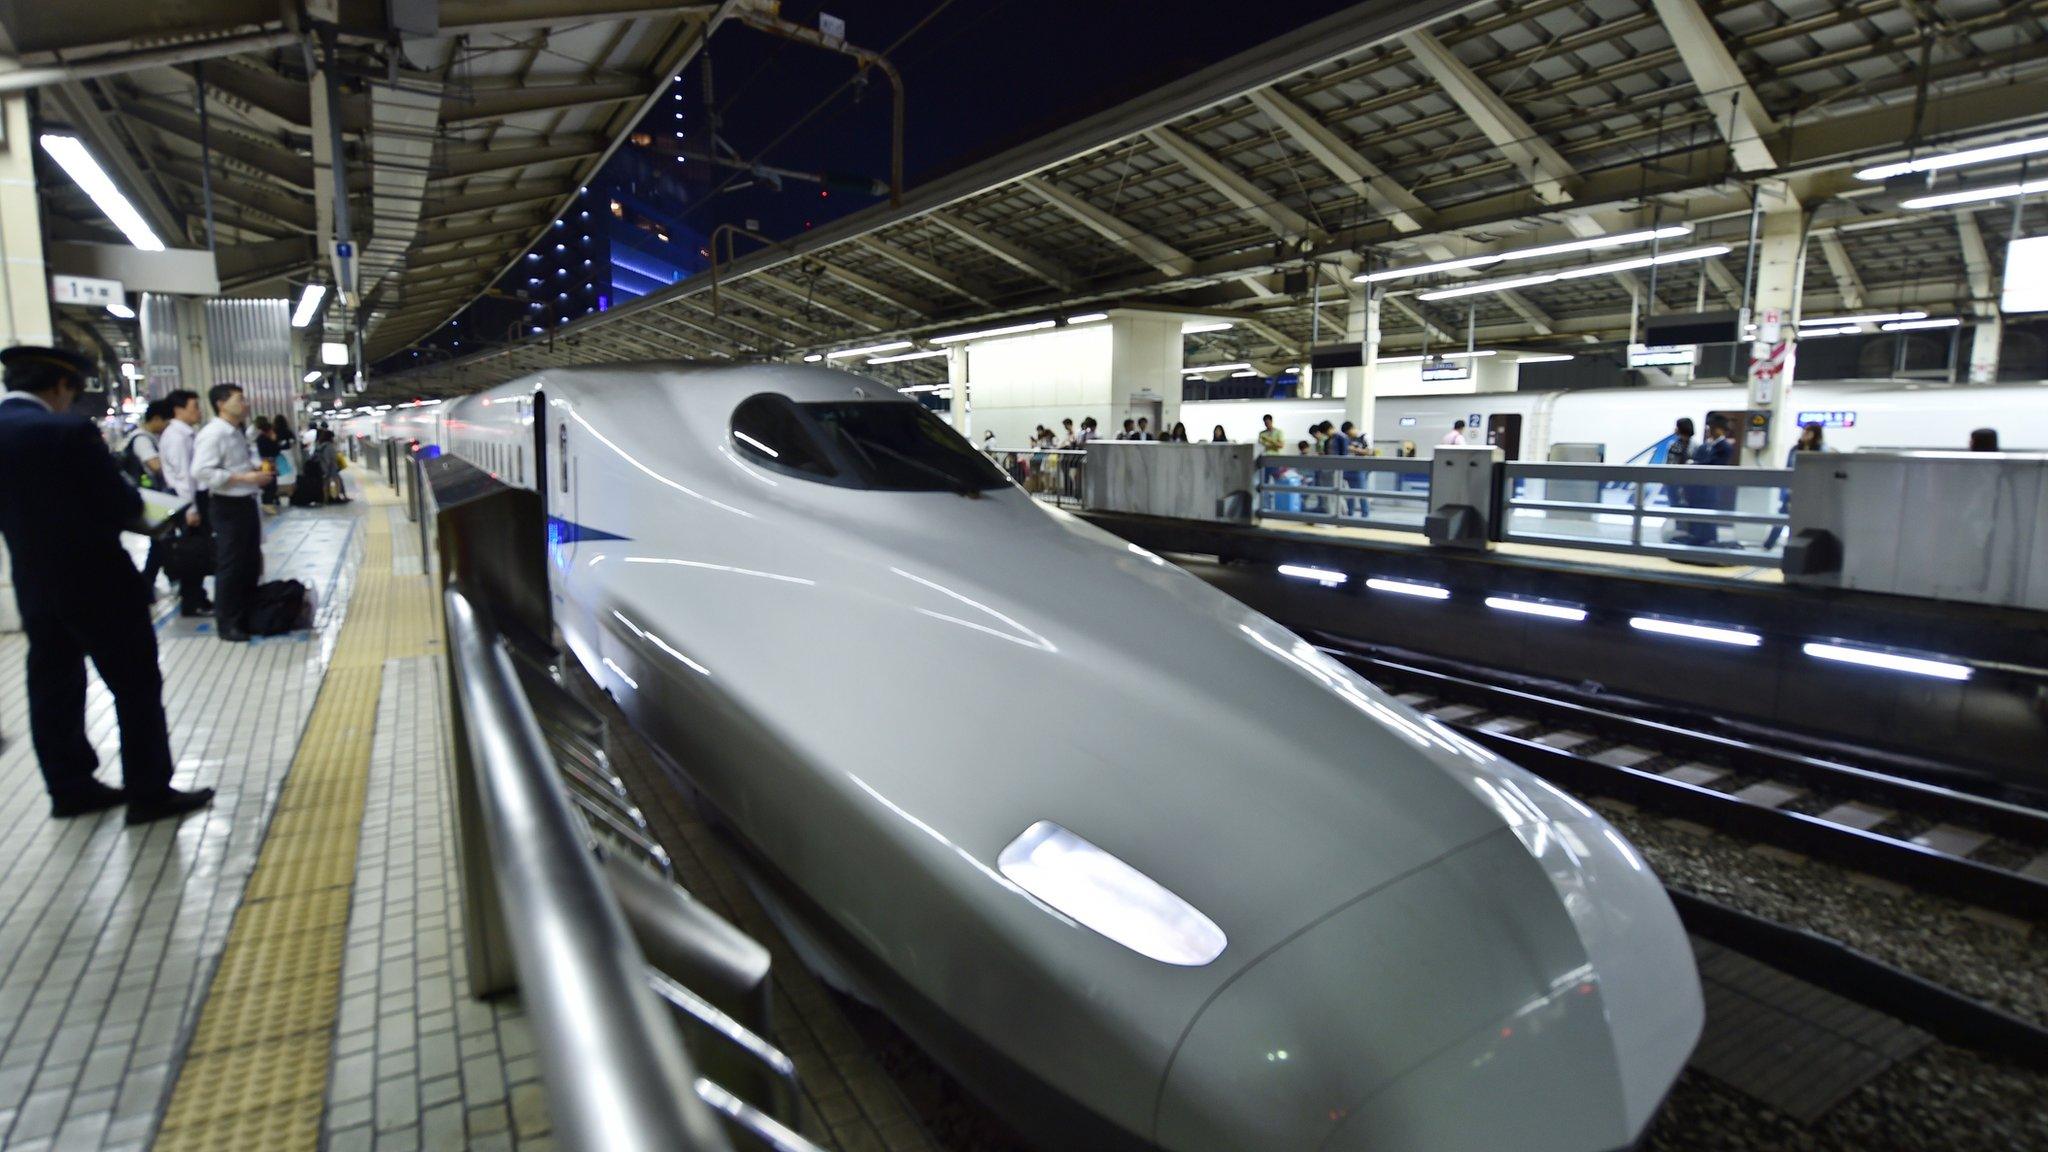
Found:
[1155,820,1700,1152]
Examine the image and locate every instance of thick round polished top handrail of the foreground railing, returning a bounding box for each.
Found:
[442,584,731,1152]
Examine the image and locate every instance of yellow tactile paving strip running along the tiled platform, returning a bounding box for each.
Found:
[156,488,440,1152]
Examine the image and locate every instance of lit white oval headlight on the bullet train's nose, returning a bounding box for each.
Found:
[995,820,1229,968]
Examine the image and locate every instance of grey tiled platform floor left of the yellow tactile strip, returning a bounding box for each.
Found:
[0,498,356,1152]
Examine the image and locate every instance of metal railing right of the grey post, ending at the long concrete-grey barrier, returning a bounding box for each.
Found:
[1499,463,1792,564]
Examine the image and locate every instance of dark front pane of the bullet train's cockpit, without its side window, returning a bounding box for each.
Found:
[801,400,1010,492]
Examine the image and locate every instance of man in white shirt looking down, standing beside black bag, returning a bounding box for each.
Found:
[193,383,270,642]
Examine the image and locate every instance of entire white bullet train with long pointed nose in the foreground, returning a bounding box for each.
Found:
[387,365,1702,1152]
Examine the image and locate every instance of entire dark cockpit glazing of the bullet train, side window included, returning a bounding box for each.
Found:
[733,394,1010,492]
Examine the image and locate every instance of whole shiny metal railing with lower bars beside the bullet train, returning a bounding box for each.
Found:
[442,584,815,1152]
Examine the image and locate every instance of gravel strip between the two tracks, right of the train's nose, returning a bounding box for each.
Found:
[1591,799,2048,1025]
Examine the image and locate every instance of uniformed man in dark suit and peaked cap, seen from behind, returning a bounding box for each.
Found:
[0,346,213,824]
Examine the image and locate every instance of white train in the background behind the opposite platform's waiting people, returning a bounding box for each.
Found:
[1196,383,2048,463]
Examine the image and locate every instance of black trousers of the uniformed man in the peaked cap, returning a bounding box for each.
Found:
[23,594,170,799]
